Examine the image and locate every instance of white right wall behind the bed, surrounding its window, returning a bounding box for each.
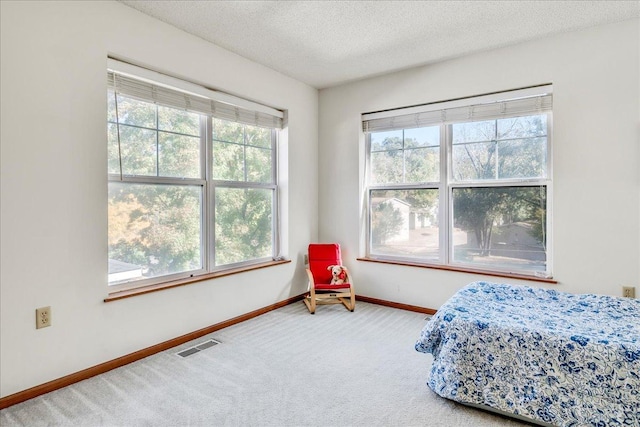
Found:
[319,20,640,308]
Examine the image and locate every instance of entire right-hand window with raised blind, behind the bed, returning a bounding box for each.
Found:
[363,86,552,277]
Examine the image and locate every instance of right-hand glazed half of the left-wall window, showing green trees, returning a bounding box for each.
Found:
[212,119,277,265]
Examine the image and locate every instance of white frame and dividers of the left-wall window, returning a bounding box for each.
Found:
[107,58,285,293]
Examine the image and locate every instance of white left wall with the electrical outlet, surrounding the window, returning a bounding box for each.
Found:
[0,1,318,396]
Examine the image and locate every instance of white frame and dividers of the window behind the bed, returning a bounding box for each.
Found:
[362,85,553,279]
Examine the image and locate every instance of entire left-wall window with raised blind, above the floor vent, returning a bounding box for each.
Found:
[107,60,283,290]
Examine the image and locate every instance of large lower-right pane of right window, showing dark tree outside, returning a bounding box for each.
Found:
[452,186,547,272]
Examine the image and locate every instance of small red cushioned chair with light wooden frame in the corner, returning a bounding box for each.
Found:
[304,243,356,314]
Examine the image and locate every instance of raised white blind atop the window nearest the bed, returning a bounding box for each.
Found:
[362,85,553,132]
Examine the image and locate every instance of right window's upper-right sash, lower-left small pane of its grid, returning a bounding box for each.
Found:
[451,141,496,181]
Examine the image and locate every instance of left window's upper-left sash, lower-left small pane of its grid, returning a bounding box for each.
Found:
[120,125,157,176]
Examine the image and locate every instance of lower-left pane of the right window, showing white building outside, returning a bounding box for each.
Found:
[370,189,440,261]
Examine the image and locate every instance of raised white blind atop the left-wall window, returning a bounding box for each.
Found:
[107,59,285,129]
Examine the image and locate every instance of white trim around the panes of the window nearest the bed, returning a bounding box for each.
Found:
[359,85,553,282]
